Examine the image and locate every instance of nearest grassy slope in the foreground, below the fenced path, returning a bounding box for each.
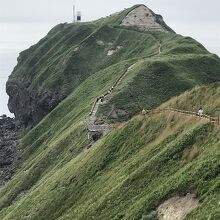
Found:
[0,102,220,220]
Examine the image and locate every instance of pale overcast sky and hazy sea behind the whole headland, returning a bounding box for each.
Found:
[0,0,220,115]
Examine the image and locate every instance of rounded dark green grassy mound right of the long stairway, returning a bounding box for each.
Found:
[99,54,220,122]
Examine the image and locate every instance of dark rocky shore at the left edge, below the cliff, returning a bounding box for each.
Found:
[0,116,21,186]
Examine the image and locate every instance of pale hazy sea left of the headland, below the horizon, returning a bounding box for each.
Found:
[0,23,55,116]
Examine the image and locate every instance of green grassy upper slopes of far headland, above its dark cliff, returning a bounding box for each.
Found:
[10,6,219,104]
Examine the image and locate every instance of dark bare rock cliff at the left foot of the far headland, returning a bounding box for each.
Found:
[6,79,65,128]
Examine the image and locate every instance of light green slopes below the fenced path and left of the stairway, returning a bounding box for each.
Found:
[0,82,220,220]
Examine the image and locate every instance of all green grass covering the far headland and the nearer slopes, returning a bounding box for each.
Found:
[0,3,220,220]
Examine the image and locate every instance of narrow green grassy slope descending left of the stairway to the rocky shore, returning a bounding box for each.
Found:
[2,59,131,211]
